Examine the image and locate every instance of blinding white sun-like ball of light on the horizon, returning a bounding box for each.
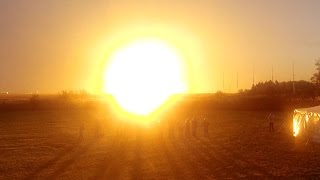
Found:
[103,39,187,116]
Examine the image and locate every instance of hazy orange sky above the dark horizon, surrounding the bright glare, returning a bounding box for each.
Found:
[0,0,320,93]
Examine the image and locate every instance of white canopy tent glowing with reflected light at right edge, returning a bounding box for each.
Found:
[293,106,320,142]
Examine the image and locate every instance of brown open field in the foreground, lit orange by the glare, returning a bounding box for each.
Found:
[0,110,320,179]
